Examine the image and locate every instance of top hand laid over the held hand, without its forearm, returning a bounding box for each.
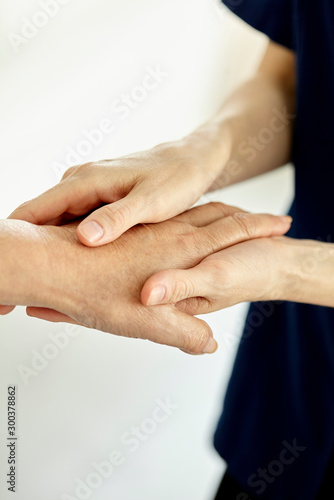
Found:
[9,136,227,246]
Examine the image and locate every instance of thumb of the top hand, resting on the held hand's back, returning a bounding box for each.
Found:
[77,195,144,247]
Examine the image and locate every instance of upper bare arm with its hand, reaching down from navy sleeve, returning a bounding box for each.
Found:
[11,43,295,246]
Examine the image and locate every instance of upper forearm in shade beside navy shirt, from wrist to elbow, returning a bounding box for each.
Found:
[179,41,295,190]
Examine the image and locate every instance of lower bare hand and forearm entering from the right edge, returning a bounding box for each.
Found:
[141,237,334,314]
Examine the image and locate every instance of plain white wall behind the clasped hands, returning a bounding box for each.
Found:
[0,0,293,500]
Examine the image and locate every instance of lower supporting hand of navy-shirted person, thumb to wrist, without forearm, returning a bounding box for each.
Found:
[141,237,292,315]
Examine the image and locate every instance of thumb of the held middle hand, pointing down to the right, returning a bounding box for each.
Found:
[138,306,217,354]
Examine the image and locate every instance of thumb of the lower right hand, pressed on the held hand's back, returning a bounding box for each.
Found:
[141,264,212,306]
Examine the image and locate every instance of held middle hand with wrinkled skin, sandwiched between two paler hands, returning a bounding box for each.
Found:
[17,203,290,354]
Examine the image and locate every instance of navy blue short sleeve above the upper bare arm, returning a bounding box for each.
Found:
[222,0,294,49]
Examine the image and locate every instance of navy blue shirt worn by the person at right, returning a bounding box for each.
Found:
[214,0,334,500]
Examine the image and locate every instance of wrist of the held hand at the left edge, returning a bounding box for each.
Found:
[0,220,79,311]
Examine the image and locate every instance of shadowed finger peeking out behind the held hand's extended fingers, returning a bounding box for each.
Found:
[175,202,244,227]
